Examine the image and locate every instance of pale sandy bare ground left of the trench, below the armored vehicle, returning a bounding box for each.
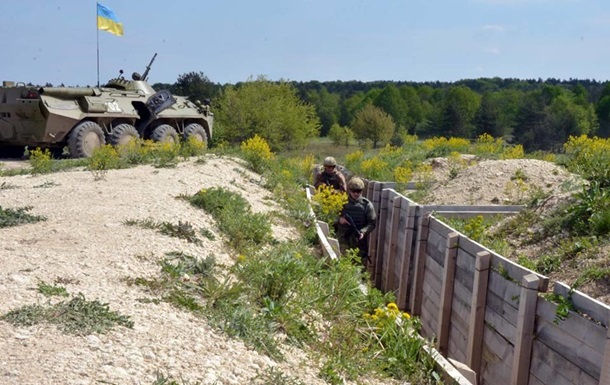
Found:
[0,155,400,385]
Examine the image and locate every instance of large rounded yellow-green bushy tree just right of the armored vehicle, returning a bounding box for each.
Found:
[215,76,320,151]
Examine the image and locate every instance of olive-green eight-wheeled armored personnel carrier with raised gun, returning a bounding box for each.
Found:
[0,54,214,158]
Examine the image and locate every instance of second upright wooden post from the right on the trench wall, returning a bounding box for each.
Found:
[466,252,491,373]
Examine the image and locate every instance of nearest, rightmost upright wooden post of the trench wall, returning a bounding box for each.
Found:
[511,274,540,385]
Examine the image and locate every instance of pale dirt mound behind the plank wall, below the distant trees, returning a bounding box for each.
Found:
[422,159,582,206]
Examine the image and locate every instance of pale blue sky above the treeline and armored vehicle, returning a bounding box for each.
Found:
[0,0,610,86]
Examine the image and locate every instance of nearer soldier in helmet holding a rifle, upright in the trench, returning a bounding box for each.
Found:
[337,177,377,268]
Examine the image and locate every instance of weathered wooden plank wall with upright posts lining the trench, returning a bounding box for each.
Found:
[314,182,610,385]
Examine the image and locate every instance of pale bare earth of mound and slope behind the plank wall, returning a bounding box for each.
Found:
[416,156,610,303]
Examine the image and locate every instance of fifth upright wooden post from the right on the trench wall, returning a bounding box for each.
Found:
[397,198,417,309]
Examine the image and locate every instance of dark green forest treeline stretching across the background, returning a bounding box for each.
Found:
[154,72,610,152]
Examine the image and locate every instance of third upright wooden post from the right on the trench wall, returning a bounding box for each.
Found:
[436,233,460,355]
